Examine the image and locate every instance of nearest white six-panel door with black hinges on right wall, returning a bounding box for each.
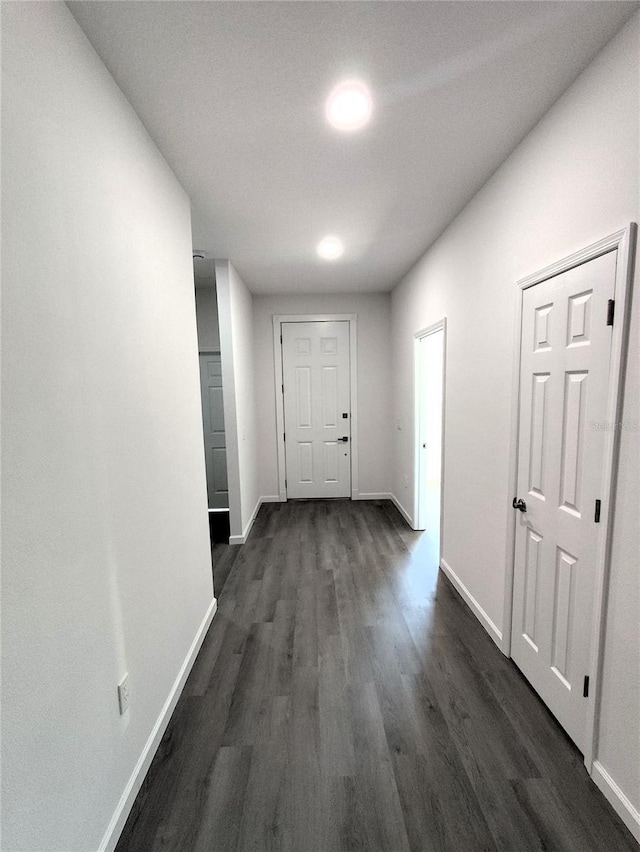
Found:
[511,251,616,750]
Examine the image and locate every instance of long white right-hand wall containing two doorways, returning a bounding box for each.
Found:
[392,15,640,832]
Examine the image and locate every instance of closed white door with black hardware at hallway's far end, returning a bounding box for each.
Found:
[281,321,351,498]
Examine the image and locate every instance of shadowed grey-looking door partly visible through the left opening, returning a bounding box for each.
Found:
[200,353,229,509]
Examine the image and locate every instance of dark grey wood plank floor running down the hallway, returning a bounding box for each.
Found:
[117,501,638,852]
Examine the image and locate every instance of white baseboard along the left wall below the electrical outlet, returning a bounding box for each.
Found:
[98,598,218,852]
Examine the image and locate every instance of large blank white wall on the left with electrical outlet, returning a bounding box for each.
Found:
[2,3,213,852]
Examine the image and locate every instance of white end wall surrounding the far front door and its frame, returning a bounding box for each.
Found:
[253,293,391,498]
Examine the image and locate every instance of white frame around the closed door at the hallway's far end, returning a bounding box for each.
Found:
[273,314,360,503]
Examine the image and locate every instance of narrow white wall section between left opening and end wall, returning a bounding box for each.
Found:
[215,260,259,544]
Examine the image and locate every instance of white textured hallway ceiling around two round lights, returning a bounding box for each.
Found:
[68,0,638,293]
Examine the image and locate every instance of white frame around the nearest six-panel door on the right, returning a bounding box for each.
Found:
[501,222,637,772]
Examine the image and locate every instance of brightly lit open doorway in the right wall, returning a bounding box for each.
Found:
[414,319,446,565]
